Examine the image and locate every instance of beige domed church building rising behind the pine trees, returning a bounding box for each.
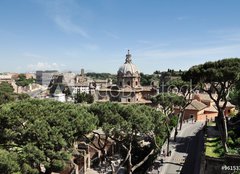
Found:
[96,51,157,104]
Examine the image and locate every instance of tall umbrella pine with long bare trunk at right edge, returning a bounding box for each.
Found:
[183,58,240,152]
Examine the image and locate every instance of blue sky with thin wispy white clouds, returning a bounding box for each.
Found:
[0,0,240,73]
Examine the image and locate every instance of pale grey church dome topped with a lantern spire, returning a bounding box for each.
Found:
[118,50,139,75]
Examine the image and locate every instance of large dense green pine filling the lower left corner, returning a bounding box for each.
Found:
[0,99,97,174]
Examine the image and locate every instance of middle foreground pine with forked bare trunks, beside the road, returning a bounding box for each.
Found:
[90,103,166,173]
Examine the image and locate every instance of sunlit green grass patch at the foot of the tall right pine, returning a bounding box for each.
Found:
[205,137,224,158]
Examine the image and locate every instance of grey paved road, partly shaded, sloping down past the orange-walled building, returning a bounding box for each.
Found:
[149,122,204,174]
